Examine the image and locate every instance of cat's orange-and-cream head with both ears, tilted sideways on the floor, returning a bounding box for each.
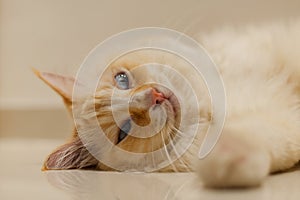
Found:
[36,50,210,170]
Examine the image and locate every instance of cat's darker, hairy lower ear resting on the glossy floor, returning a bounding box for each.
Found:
[42,136,98,170]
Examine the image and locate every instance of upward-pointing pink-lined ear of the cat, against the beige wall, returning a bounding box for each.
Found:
[32,69,75,102]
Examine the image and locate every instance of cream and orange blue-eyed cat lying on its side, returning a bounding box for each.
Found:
[35,20,300,187]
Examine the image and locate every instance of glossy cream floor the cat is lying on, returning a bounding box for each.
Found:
[0,139,300,200]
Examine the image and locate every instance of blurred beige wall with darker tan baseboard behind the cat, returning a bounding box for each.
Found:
[0,0,300,140]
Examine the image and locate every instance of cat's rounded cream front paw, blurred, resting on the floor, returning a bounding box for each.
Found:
[196,127,270,187]
